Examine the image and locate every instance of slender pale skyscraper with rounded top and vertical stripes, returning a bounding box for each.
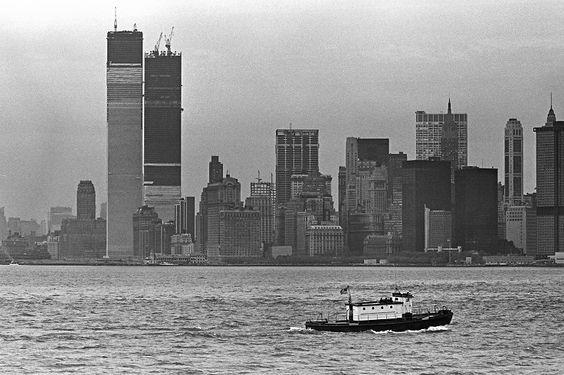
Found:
[504,118,523,205]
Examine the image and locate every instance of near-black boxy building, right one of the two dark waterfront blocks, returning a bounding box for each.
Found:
[454,167,498,251]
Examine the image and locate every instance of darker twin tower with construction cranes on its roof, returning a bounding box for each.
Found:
[143,39,182,222]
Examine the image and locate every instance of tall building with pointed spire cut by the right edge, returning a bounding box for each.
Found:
[528,105,564,258]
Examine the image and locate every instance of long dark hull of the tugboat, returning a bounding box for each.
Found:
[305,310,452,332]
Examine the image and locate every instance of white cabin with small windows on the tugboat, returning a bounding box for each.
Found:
[346,292,413,322]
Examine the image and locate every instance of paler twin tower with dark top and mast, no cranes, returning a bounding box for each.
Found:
[106,23,143,258]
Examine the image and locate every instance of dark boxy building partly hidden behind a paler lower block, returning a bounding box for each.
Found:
[402,160,451,251]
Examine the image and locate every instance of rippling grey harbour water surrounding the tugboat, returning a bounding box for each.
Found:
[0,266,564,374]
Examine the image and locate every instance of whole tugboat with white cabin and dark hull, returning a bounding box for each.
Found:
[305,286,452,332]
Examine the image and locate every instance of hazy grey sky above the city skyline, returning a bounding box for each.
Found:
[0,0,564,220]
